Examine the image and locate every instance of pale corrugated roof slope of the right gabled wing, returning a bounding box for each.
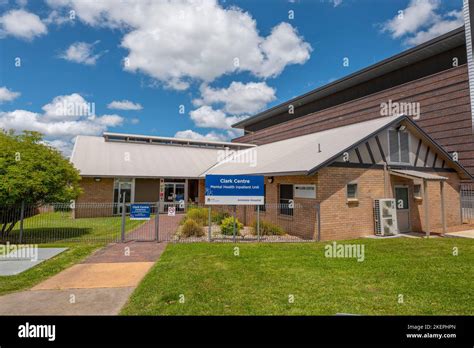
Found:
[203,116,403,175]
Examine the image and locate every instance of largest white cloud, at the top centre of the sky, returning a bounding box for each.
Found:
[47,0,311,90]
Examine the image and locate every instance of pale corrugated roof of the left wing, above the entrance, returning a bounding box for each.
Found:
[71,136,231,178]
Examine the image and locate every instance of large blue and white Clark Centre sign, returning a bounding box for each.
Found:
[205,175,265,205]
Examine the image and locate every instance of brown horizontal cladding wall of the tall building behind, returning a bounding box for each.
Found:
[234,65,474,173]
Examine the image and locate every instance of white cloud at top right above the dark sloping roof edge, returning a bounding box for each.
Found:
[382,0,463,45]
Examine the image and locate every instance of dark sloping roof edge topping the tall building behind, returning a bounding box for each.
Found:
[232,26,466,128]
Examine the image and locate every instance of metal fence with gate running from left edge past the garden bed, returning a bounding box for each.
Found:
[0,202,320,243]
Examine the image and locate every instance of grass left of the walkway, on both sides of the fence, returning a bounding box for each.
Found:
[0,212,144,295]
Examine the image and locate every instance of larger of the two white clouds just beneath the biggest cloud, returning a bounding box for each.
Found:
[193,82,276,115]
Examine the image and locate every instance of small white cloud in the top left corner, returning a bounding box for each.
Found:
[0,10,48,41]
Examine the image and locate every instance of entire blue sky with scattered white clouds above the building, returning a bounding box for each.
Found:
[0,0,463,156]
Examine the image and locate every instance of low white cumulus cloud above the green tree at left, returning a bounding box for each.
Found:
[0,93,124,155]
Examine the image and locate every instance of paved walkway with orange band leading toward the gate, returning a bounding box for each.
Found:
[0,242,166,315]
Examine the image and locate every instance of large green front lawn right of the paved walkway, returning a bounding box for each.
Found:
[122,238,474,315]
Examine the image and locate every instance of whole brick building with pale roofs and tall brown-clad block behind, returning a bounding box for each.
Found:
[72,20,474,240]
